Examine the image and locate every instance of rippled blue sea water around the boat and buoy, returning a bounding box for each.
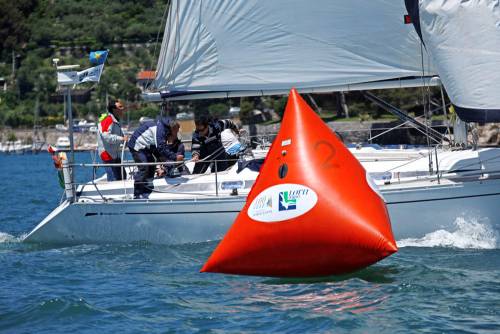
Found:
[0,153,500,333]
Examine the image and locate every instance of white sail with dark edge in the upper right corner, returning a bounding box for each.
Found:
[405,0,500,122]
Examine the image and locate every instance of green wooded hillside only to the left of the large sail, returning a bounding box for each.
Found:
[0,0,166,127]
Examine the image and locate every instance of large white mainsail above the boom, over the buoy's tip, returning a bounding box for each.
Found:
[149,0,434,99]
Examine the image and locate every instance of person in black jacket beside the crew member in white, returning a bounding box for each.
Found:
[191,115,239,174]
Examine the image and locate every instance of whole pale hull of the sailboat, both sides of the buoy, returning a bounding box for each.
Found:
[26,172,500,245]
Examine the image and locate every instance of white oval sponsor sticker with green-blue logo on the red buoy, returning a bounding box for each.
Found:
[248,183,318,223]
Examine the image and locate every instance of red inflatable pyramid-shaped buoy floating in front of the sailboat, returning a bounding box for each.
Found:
[201,89,397,277]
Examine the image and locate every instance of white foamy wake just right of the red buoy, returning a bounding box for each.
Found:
[397,217,499,249]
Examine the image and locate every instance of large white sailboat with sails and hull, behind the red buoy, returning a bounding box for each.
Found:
[26,0,500,244]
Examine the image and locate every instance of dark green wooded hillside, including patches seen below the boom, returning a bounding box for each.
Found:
[0,0,450,132]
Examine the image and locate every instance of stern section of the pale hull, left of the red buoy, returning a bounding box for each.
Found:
[26,197,245,245]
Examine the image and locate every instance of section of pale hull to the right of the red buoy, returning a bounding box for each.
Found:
[382,179,500,240]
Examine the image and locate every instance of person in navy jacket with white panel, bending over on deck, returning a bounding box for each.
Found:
[127,117,181,198]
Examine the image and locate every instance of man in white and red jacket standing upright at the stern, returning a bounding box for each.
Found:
[97,100,128,181]
